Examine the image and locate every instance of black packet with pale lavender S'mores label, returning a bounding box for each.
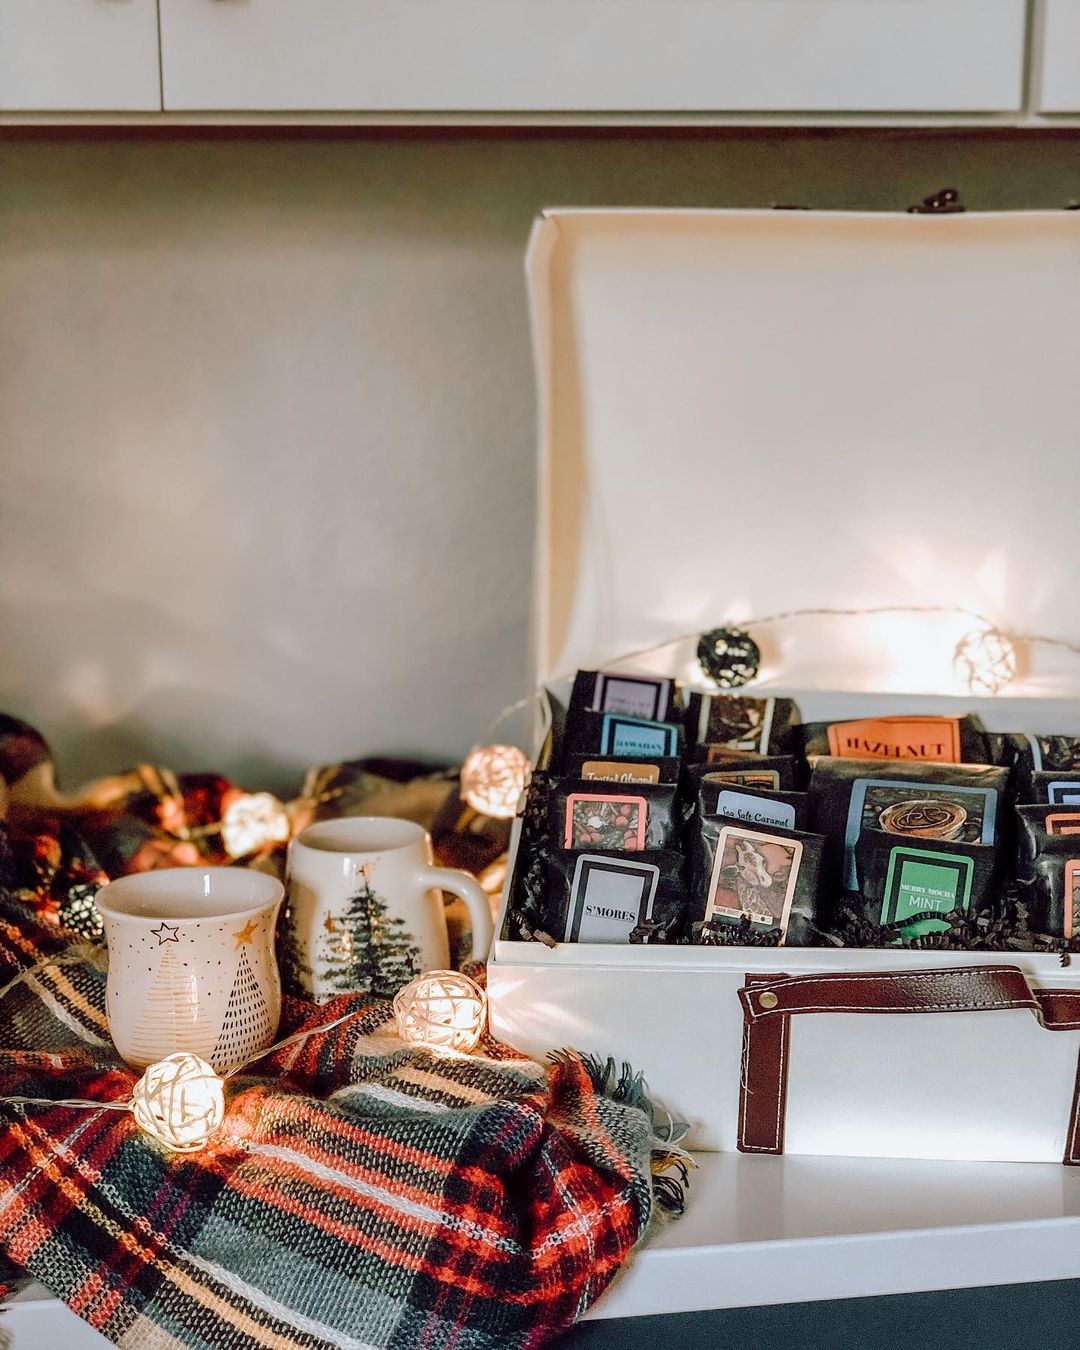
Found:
[547,848,687,942]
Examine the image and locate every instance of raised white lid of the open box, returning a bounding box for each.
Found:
[528,209,1080,730]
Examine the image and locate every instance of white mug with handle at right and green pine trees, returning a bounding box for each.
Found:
[282,815,494,1000]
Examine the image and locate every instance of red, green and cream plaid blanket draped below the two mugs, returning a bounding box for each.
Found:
[0,898,684,1350]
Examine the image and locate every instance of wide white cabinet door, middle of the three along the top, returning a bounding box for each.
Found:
[161,0,1025,112]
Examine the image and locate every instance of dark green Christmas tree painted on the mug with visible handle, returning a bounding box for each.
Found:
[323,873,420,999]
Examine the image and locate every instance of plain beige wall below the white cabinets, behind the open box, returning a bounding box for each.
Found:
[0,132,1080,787]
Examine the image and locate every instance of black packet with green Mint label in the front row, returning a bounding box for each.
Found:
[856,829,998,942]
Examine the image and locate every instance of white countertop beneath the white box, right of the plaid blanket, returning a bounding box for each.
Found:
[589,1154,1080,1319]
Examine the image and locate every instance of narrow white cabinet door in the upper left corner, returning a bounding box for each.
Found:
[0,0,161,112]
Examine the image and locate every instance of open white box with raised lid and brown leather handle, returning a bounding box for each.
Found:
[489,211,1080,1161]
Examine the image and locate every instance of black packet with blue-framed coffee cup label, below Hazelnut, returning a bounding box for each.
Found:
[810,755,1008,891]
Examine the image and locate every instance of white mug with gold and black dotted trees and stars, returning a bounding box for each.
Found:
[95,867,285,1072]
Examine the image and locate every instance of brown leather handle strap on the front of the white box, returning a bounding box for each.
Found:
[738,965,1080,1165]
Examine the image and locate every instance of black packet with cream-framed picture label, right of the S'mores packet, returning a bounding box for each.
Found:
[691,815,824,946]
